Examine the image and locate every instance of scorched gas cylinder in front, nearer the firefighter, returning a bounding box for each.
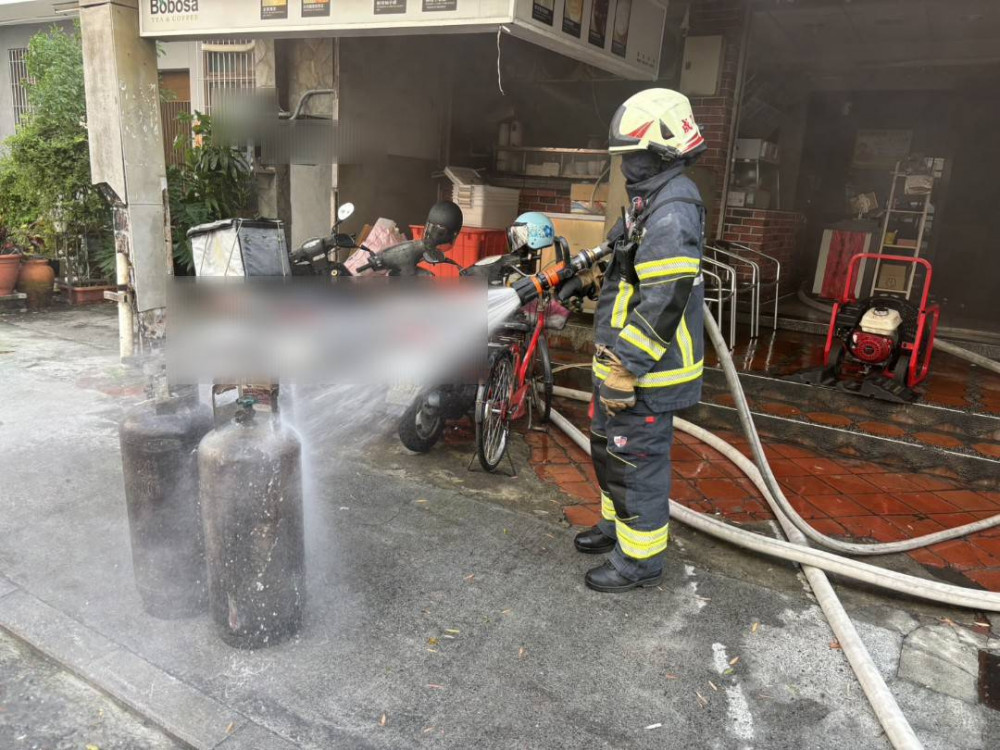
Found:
[198,398,305,648]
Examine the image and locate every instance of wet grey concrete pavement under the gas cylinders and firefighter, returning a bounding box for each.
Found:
[0,308,1000,750]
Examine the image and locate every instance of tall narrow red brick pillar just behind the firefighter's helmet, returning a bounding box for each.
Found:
[688,0,746,237]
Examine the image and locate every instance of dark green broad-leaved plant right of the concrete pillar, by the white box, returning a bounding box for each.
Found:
[167,112,256,271]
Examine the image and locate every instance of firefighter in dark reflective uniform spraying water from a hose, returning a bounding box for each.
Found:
[574,89,705,593]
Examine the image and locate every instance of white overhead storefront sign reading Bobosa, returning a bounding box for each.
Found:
[139,0,666,80]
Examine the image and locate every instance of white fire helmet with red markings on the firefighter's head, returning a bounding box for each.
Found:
[608,89,705,160]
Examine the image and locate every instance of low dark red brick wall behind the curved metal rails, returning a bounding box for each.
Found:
[722,206,810,292]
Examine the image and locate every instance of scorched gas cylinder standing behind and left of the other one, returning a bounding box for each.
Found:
[118,393,212,619]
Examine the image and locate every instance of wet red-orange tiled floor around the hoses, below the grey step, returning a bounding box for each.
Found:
[536,401,1000,591]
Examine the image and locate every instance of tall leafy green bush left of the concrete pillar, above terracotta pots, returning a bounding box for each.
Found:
[0,27,111,266]
